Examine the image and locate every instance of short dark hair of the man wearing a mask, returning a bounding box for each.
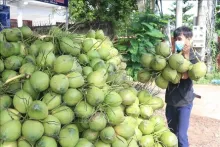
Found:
[173,26,193,39]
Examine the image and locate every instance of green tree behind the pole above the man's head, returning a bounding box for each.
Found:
[164,0,194,27]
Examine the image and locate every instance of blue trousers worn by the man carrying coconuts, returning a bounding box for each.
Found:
[166,104,193,147]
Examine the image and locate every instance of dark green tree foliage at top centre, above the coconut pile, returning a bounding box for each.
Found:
[69,0,137,22]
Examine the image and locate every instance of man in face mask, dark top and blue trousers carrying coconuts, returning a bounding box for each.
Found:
[165,26,197,147]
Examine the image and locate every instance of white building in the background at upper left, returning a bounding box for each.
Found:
[0,0,66,27]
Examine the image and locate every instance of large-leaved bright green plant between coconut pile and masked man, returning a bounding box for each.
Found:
[115,11,167,80]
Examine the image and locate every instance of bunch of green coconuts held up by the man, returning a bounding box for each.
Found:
[138,42,207,89]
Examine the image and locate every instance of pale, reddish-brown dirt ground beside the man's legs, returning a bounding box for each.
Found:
[157,85,220,147]
